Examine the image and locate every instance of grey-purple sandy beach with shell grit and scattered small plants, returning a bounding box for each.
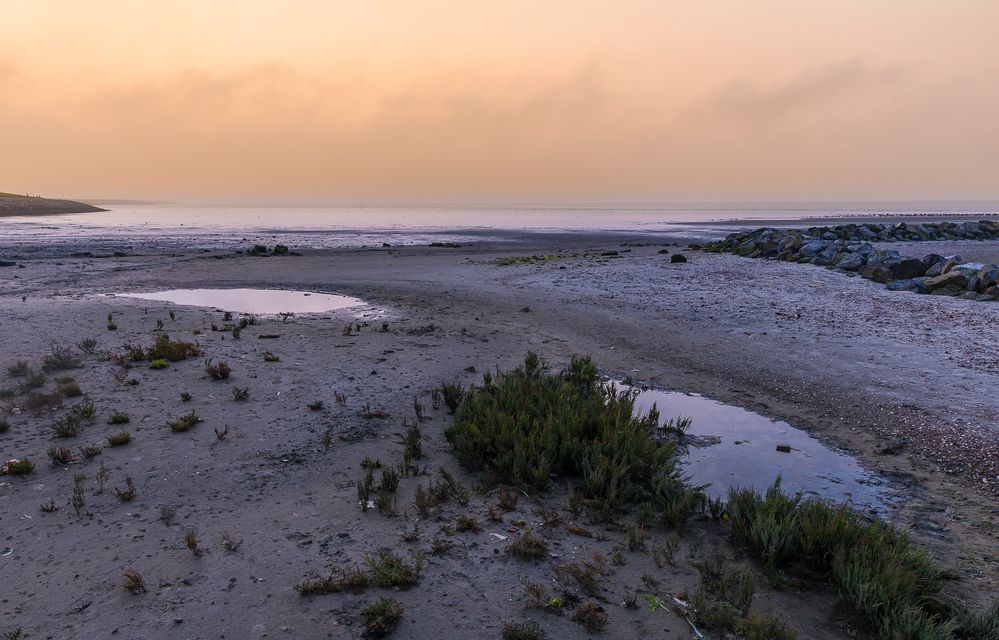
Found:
[0,233,999,638]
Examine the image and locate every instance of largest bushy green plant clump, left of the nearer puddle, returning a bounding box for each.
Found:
[443,353,704,527]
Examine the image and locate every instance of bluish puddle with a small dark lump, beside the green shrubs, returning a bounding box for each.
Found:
[635,390,897,515]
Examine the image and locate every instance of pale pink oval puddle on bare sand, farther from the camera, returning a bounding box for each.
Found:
[116,289,364,314]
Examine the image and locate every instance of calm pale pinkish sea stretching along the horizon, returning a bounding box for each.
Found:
[0,202,999,250]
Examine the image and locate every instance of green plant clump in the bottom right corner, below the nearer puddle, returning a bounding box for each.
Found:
[727,480,999,640]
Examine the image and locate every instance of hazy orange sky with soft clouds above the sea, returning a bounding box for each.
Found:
[0,0,999,201]
